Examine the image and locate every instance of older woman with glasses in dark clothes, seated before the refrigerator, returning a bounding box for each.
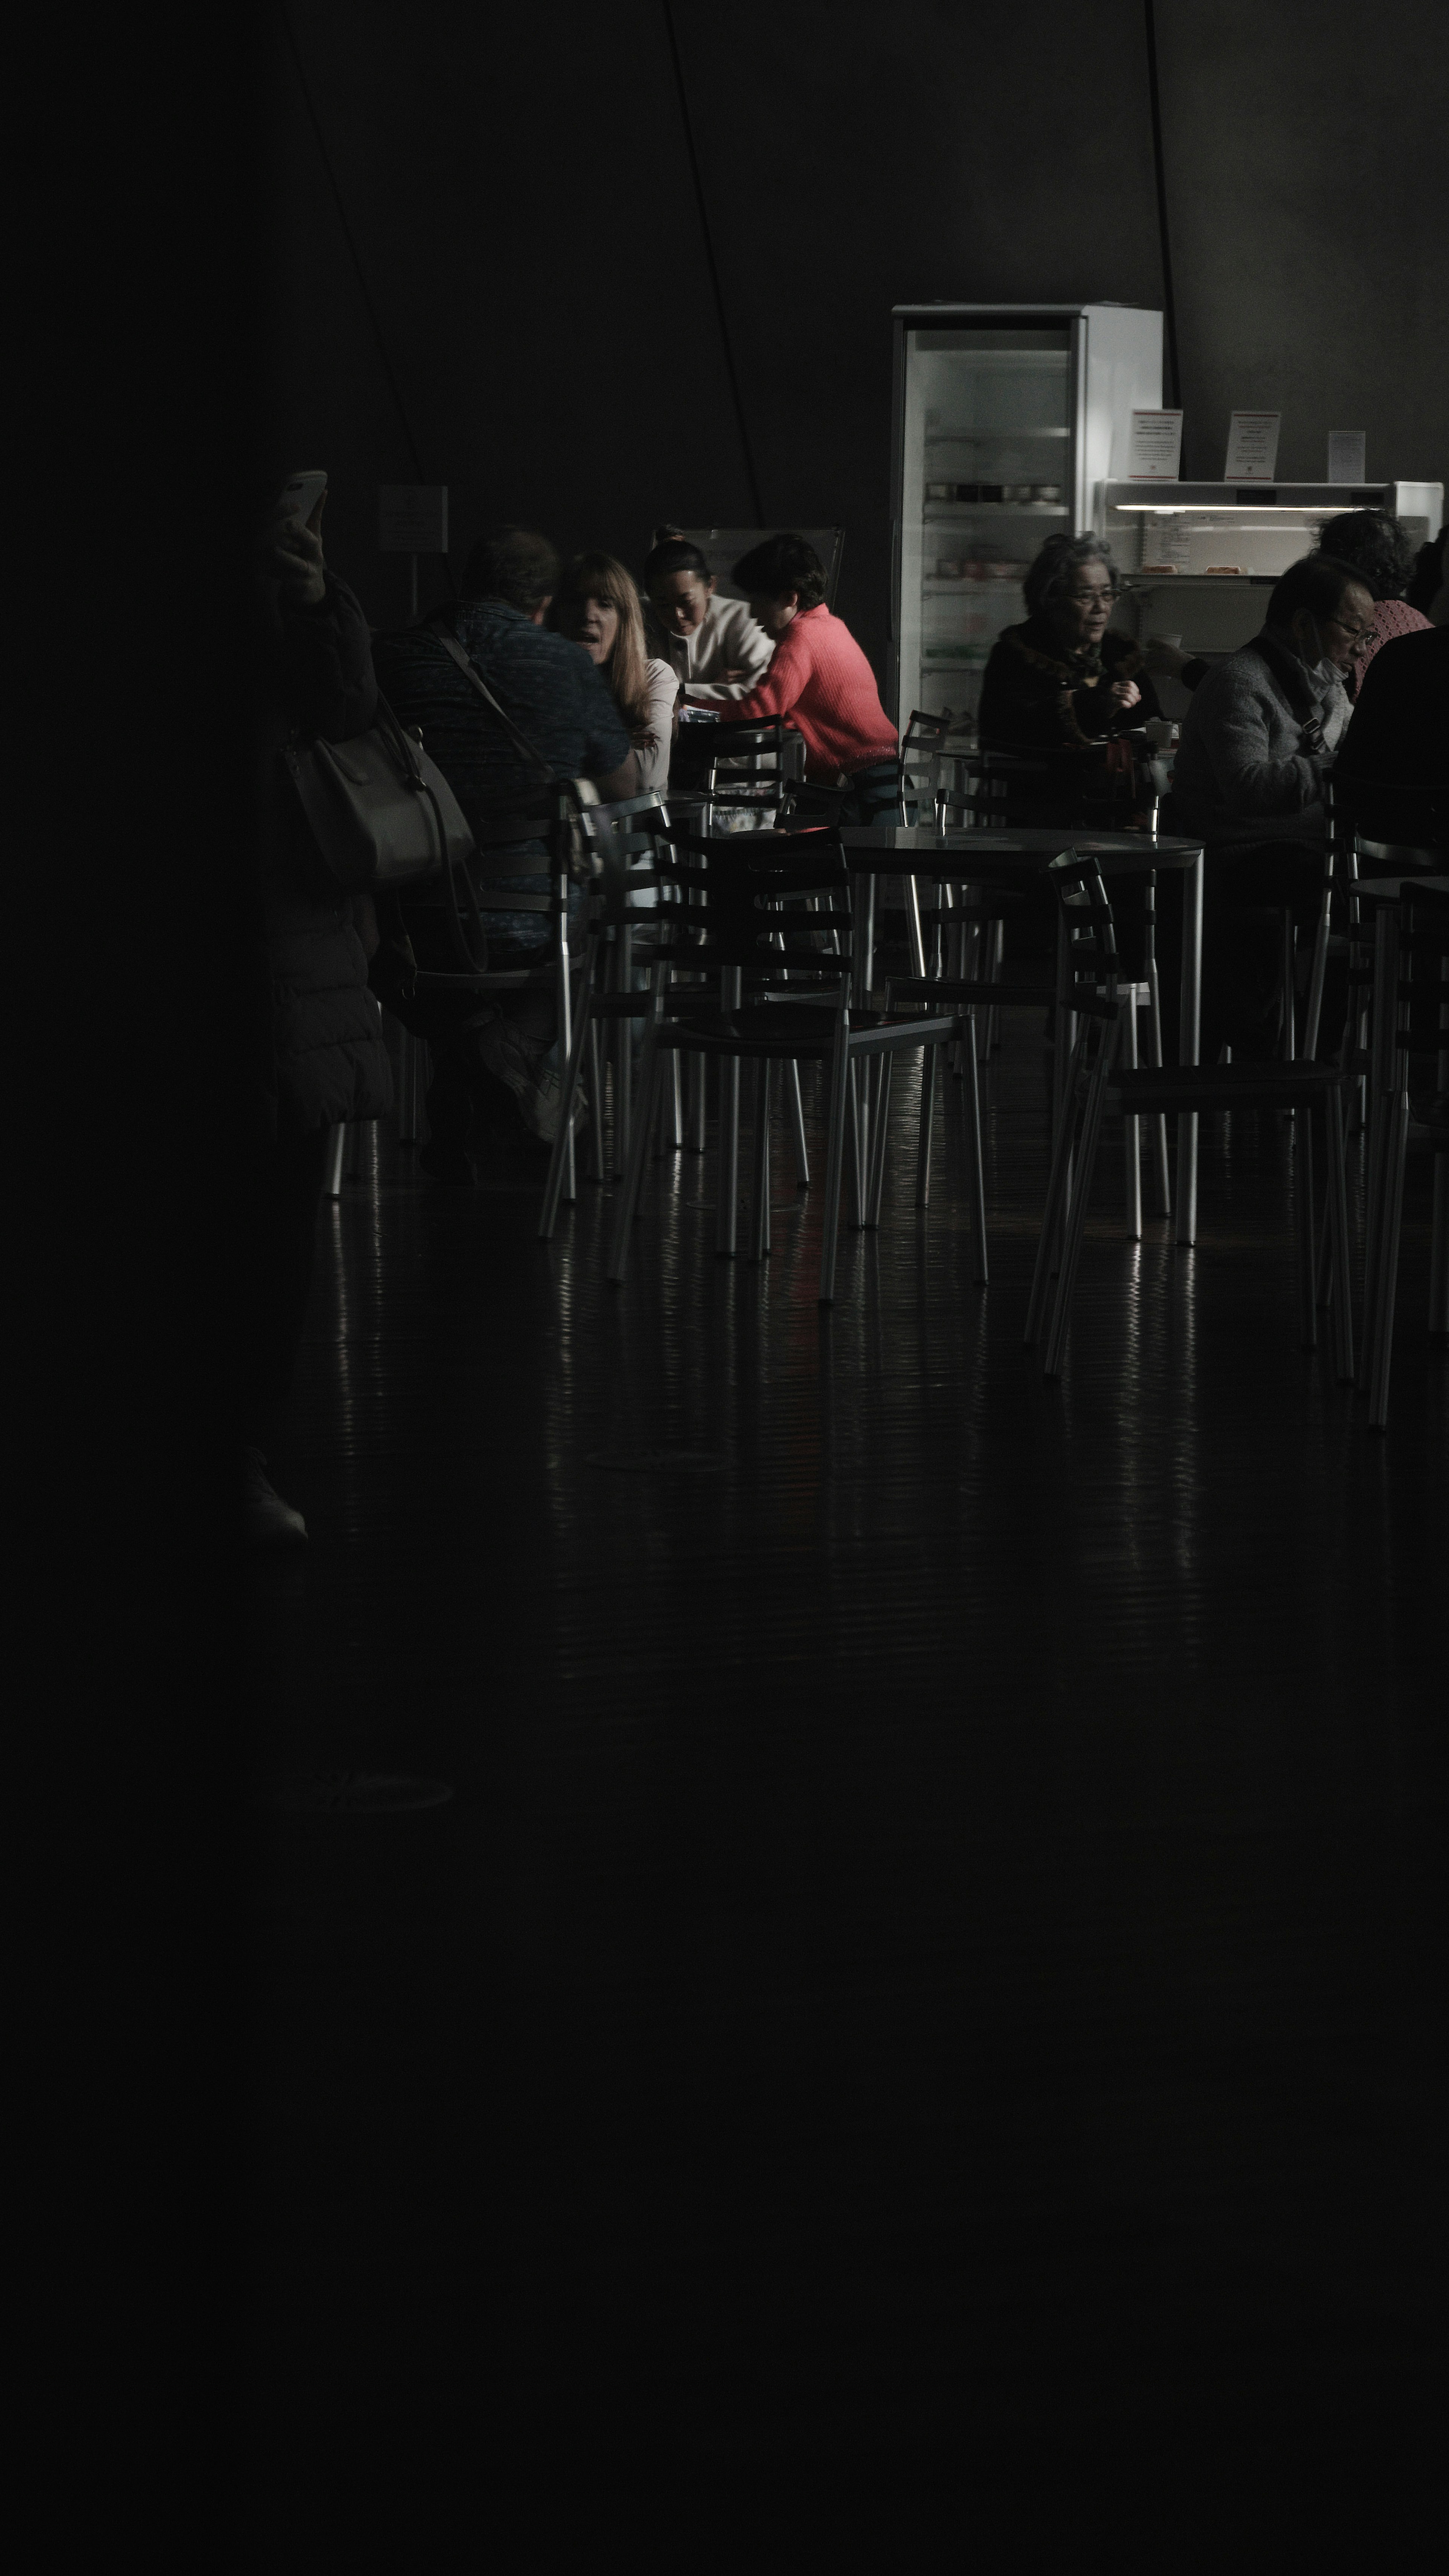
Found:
[980,536,1163,822]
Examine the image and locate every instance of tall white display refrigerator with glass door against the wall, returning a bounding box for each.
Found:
[887,304,1163,734]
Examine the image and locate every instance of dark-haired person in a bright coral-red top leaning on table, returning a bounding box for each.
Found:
[686,533,900,822]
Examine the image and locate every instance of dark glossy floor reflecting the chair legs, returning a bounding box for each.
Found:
[250,1015,1449,2568]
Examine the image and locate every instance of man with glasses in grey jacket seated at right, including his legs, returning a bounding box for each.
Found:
[1163,554,1374,1064]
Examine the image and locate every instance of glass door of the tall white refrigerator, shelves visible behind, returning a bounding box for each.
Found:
[897,320,1078,734]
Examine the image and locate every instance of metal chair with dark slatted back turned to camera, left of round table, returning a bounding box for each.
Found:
[609,832,959,1306]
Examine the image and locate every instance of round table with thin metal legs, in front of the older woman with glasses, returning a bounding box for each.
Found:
[840,824,1201,1244]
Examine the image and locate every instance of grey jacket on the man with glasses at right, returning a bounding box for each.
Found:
[1171,629,1351,842]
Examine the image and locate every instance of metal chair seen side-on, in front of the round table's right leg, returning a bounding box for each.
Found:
[1024,850,1354,1381]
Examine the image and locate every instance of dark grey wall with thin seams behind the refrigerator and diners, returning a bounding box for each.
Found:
[271,0,1449,667]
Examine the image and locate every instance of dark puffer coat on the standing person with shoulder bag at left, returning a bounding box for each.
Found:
[258,572,392,1133]
